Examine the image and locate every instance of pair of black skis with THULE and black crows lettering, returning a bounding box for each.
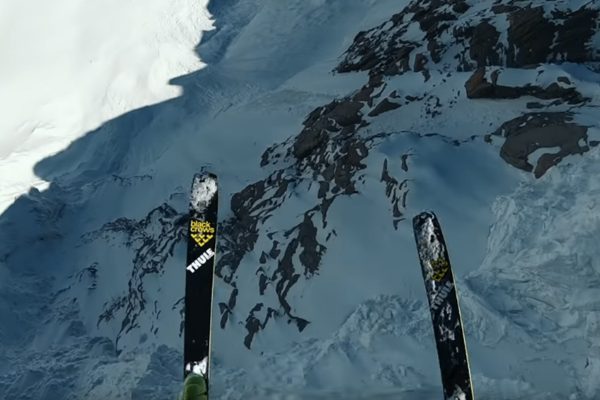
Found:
[183,174,473,400]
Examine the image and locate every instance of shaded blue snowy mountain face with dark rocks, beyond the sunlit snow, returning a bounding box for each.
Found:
[0,0,600,400]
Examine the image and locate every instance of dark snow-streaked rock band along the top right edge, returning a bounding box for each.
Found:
[336,0,600,76]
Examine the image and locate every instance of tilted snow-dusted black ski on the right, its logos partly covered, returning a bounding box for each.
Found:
[413,212,473,400]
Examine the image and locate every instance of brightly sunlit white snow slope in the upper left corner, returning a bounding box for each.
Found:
[0,0,212,211]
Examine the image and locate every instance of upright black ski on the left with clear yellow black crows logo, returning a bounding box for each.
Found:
[183,174,218,387]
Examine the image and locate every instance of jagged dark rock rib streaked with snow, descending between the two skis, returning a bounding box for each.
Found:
[216,118,376,347]
